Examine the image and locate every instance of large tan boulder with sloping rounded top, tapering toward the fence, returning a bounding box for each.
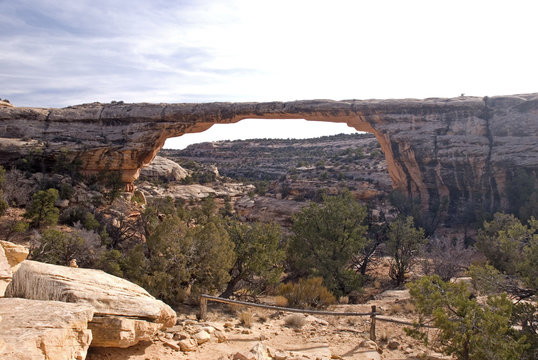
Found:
[6,260,176,347]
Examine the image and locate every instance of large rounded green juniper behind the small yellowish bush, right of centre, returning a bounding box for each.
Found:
[288,192,368,296]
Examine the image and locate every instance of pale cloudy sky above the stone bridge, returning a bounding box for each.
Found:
[0,0,538,147]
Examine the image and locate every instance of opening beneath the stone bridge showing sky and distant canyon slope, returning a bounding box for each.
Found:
[157,119,392,200]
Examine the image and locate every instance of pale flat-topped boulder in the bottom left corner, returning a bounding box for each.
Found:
[0,298,93,360]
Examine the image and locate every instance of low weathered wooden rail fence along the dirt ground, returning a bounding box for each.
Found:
[200,294,431,341]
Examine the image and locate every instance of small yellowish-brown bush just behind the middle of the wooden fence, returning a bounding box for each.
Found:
[278,277,336,309]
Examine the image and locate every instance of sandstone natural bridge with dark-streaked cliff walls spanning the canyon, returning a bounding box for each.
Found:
[0,94,538,219]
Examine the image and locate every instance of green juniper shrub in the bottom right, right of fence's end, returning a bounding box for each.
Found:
[406,275,528,360]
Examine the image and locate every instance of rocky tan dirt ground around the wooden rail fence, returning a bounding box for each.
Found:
[87,261,450,360]
